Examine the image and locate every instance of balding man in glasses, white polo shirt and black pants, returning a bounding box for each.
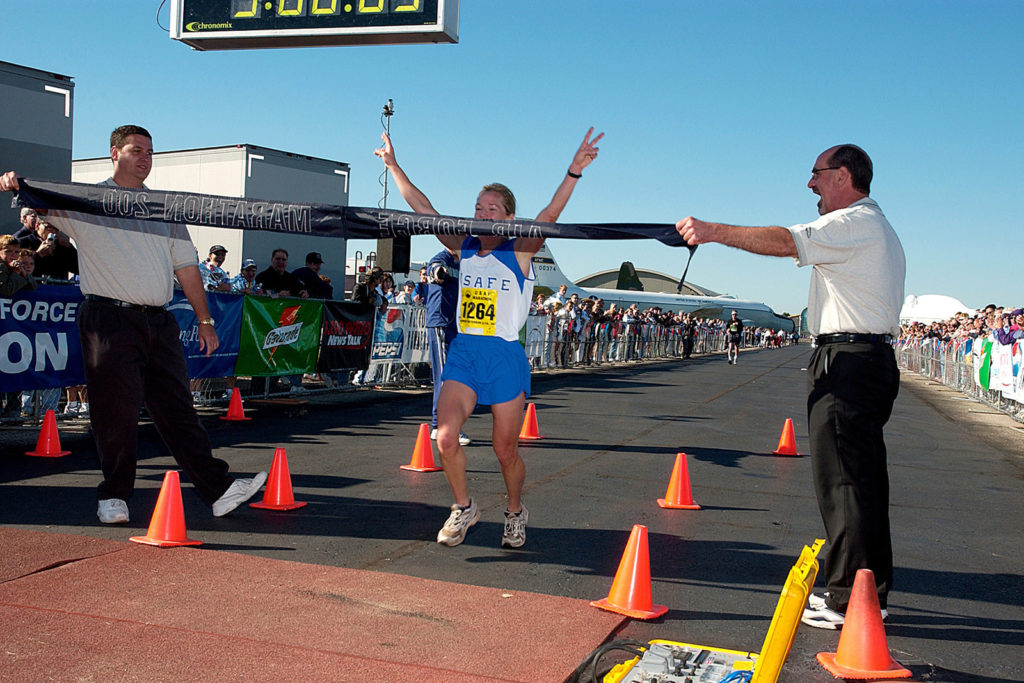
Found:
[676,144,906,630]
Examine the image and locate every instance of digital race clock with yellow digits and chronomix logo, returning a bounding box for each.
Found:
[170,0,459,50]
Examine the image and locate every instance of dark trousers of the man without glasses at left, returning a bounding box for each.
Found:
[78,301,232,505]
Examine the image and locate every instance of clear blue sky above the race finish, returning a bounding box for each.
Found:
[0,0,1024,312]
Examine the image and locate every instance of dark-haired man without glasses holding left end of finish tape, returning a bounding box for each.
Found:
[0,126,266,523]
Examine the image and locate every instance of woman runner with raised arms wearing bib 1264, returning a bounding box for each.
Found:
[374,128,604,548]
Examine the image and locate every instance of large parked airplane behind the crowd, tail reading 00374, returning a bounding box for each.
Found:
[534,244,797,333]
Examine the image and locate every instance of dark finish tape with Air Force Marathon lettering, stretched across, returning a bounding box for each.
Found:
[11,178,695,248]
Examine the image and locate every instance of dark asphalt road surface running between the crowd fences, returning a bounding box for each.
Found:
[0,345,1024,683]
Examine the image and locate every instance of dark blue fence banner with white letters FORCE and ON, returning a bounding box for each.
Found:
[0,285,85,391]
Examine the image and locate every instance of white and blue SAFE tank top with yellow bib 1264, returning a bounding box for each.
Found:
[459,237,536,341]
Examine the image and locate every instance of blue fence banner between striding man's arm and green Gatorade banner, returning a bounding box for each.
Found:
[167,290,245,378]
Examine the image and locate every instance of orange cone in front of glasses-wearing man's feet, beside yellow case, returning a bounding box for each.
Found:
[818,569,910,679]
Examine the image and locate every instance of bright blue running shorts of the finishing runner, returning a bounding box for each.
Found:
[441,334,529,405]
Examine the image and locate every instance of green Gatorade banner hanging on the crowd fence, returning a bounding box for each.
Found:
[234,297,324,377]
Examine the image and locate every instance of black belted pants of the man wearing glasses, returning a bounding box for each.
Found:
[807,342,899,612]
